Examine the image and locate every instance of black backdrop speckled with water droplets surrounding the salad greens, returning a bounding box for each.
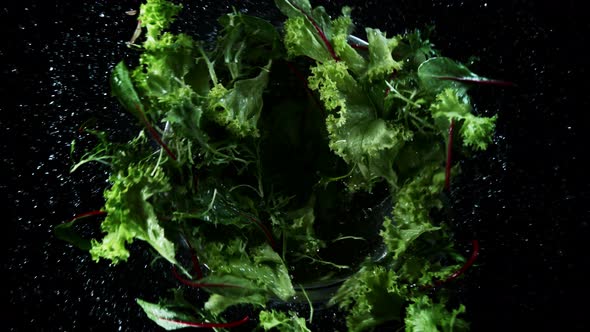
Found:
[0,0,590,331]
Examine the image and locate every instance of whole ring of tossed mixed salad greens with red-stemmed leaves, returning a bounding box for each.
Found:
[56,0,505,331]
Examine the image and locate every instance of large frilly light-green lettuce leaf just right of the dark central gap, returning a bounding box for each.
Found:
[309,60,412,188]
